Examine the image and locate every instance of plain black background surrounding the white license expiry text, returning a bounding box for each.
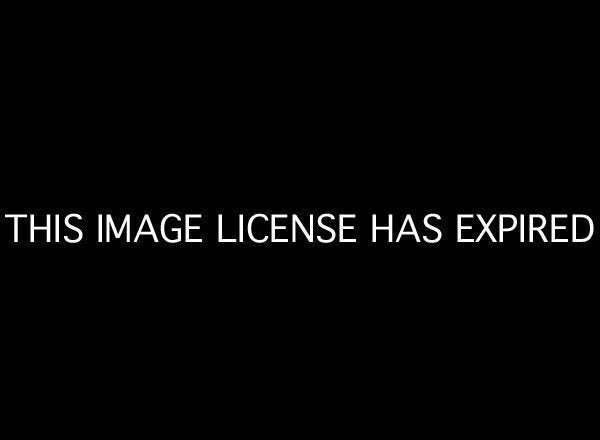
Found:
[1,5,598,433]
